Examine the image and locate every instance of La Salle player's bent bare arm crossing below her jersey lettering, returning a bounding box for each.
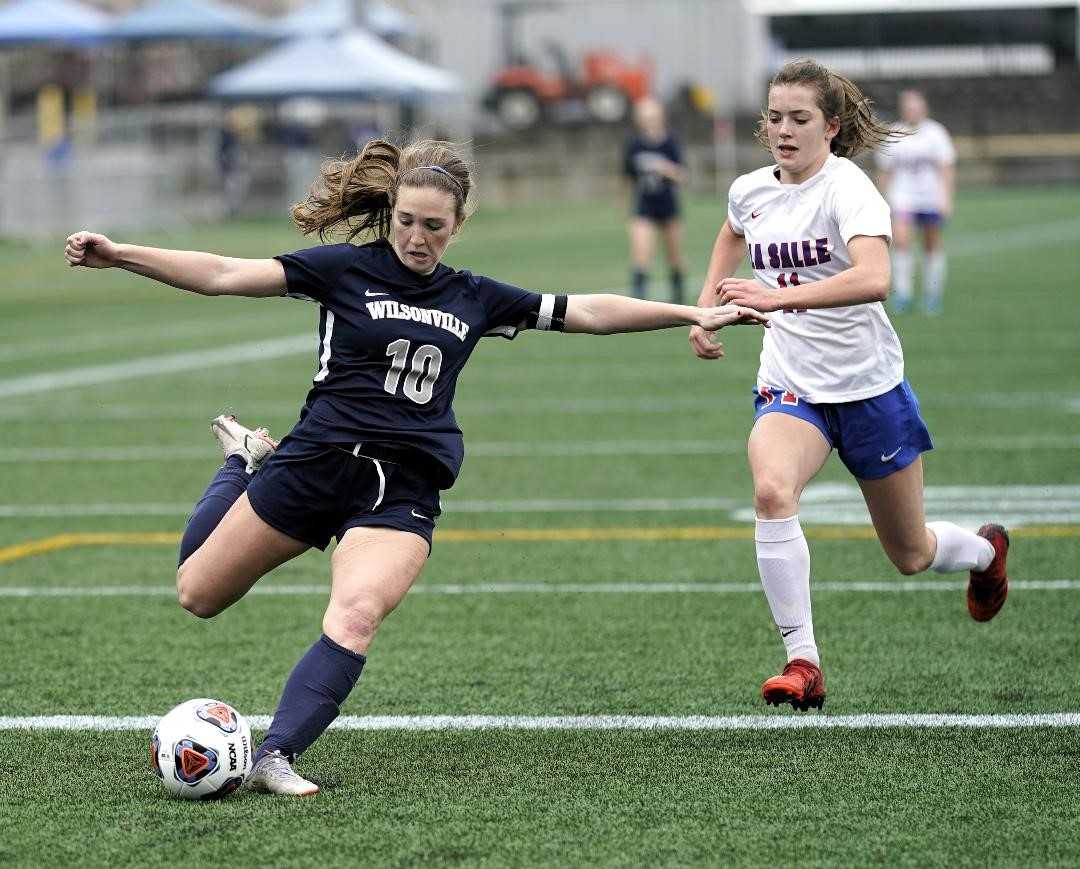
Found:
[720,235,892,311]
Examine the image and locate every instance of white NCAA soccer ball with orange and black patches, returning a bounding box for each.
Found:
[150,697,255,800]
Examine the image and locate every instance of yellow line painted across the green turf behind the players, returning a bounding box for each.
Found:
[0,525,1080,565]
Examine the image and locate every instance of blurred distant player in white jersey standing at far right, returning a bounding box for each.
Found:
[877,91,956,314]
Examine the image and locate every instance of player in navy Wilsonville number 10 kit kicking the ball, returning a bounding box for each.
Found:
[65,135,766,796]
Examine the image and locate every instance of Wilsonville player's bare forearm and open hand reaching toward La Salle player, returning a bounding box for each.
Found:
[563,294,767,335]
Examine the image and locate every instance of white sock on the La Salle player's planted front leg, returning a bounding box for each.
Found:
[754,516,821,664]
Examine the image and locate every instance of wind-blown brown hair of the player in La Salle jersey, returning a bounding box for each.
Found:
[756,59,897,157]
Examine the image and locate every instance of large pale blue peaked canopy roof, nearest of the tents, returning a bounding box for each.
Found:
[210,29,461,103]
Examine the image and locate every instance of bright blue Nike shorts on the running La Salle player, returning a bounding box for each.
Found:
[754,380,934,479]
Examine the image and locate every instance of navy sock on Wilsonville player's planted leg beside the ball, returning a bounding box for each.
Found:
[255,634,367,761]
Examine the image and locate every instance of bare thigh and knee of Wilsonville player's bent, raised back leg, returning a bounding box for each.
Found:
[176,492,310,619]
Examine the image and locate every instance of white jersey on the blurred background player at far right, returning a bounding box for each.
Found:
[877,118,956,212]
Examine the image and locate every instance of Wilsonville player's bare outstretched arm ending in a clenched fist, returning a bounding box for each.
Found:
[64,231,285,297]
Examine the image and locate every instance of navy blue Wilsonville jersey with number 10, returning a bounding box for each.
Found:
[276,241,566,488]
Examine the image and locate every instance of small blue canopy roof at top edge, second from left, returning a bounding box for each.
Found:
[108,0,270,41]
